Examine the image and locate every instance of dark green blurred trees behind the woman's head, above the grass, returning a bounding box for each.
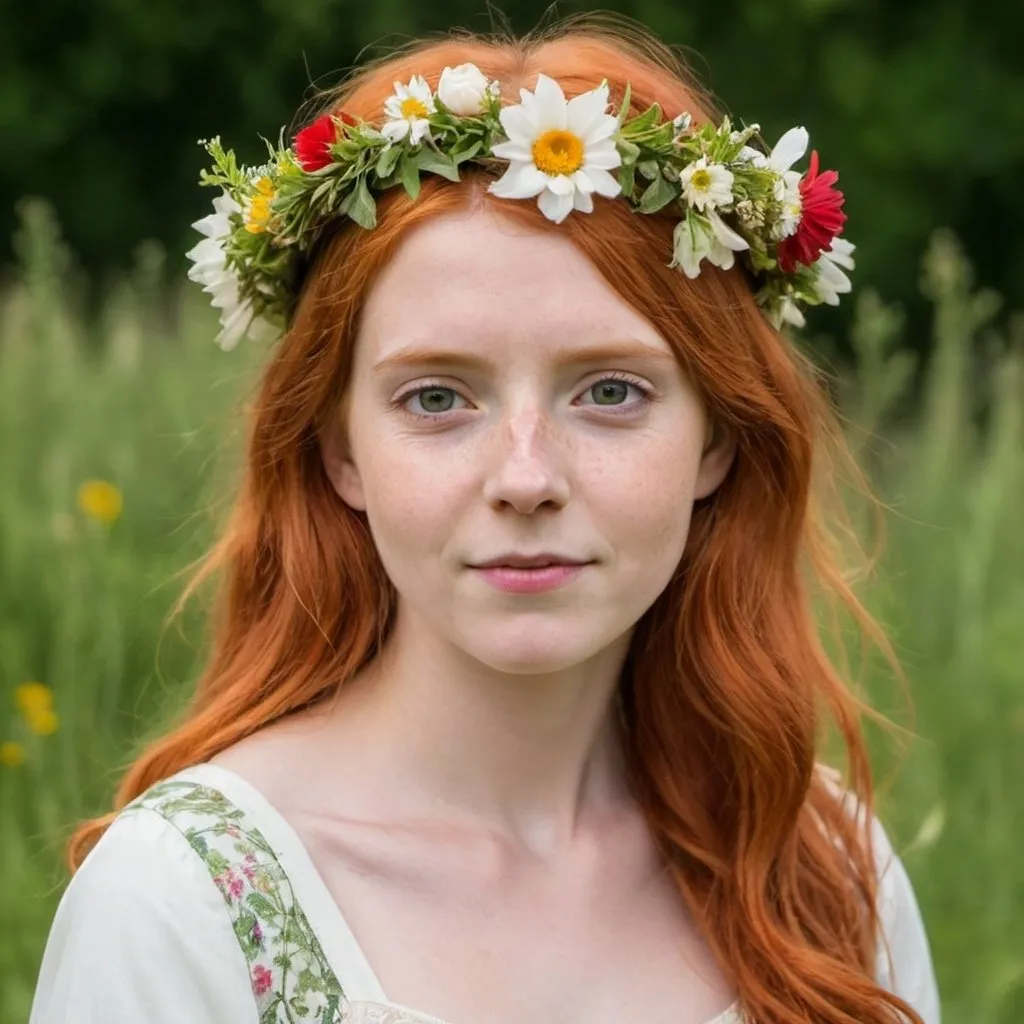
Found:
[0,0,1024,348]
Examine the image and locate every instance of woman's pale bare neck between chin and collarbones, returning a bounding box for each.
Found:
[315,602,631,855]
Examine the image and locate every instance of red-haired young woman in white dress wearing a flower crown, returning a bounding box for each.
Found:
[32,14,939,1024]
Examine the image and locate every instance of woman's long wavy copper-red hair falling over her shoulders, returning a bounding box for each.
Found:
[69,16,922,1024]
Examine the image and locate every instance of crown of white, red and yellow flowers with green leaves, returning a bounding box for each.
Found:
[187,63,854,348]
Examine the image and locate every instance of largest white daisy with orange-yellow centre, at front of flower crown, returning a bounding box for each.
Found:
[488,75,623,224]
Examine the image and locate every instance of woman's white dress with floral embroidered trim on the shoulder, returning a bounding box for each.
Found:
[29,764,940,1024]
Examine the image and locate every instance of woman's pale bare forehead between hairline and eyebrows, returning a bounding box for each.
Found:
[357,209,672,365]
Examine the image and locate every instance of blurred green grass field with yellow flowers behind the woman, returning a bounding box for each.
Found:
[0,204,1024,1024]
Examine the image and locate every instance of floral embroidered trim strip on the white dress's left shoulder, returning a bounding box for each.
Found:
[122,779,347,1024]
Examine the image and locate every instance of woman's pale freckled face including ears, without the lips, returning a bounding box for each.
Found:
[324,203,732,674]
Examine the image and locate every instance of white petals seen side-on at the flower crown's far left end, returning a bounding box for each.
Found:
[185,190,278,350]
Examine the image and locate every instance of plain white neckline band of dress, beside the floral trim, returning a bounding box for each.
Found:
[175,762,742,1024]
